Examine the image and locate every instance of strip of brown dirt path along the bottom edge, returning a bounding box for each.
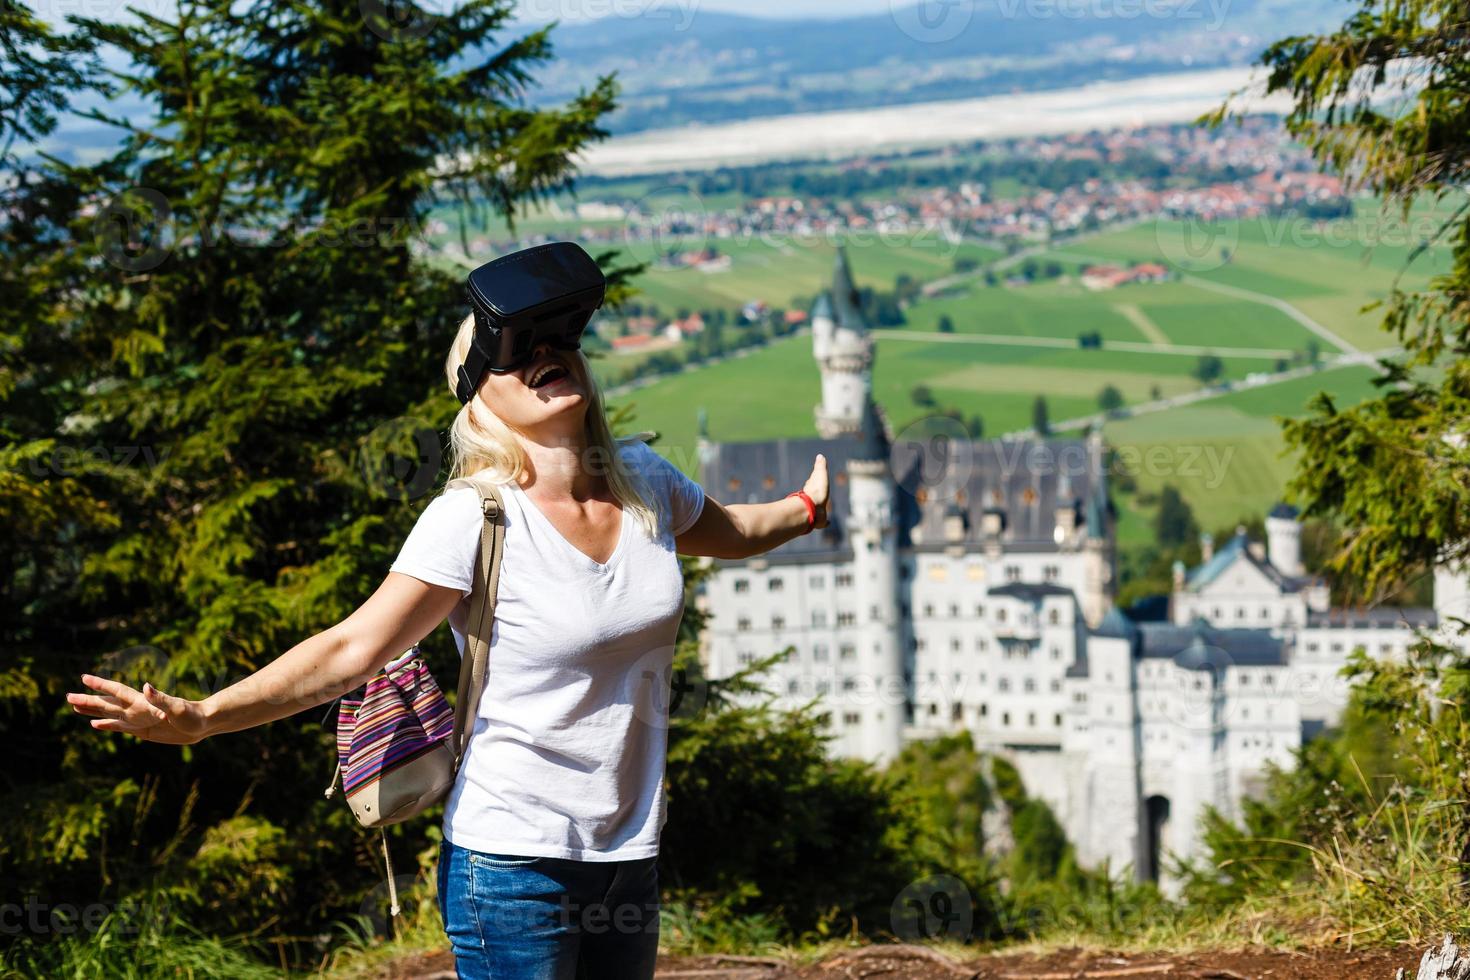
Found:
[382,946,1421,980]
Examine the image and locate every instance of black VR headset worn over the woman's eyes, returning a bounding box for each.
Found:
[454,241,607,404]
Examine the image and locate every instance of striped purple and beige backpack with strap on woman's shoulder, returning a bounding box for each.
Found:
[326,479,506,915]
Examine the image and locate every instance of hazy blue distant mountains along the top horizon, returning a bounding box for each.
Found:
[523,0,1347,132]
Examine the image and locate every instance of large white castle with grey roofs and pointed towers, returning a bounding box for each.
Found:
[700,251,1470,886]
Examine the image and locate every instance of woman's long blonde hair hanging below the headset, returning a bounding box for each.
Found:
[444,313,663,538]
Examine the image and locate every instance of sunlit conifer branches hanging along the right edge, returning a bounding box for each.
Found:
[1211,0,1470,595]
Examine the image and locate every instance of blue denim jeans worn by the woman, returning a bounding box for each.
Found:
[438,840,659,980]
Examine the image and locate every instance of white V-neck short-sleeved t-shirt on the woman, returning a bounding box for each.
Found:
[391,442,704,861]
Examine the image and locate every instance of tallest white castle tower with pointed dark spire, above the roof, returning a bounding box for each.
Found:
[811,248,873,439]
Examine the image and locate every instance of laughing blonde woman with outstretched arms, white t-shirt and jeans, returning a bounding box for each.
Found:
[68,308,828,979]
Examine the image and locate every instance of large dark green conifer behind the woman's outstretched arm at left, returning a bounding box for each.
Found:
[0,0,616,952]
